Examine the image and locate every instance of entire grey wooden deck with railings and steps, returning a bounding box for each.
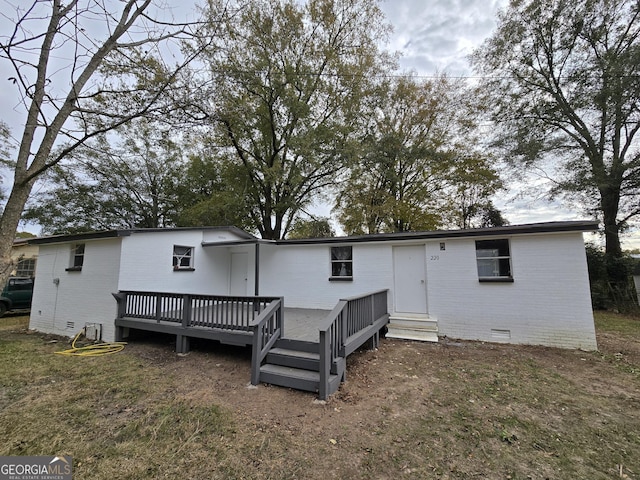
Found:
[114,290,389,399]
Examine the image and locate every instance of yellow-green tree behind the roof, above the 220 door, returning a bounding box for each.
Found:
[336,77,501,234]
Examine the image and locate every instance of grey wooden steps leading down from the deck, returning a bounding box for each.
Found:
[260,339,345,394]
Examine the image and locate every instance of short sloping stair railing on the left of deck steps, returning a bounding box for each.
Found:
[251,298,284,385]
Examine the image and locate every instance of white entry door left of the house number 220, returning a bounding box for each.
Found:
[393,245,427,314]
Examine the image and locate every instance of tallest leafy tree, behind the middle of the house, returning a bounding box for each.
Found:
[198,0,389,239]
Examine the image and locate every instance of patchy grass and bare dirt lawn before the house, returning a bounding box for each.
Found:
[0,313,640,480]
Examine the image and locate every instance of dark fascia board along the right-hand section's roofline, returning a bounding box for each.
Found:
[276,220,599,245]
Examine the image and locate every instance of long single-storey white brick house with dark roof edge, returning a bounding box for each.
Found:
[29,221,598,349]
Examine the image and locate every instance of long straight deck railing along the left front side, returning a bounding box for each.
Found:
[113,291,279,332]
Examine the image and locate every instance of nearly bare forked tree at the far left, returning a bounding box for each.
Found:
[0,0,216,284]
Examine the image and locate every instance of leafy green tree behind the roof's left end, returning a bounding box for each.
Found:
[23,119,184,233]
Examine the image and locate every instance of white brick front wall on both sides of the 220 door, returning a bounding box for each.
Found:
[261,233,596,349]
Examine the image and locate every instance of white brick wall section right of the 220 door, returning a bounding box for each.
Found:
[427,233,596,349]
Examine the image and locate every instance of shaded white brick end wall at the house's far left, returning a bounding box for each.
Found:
[29,239,120,341]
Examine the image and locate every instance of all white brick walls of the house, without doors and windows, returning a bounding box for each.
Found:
[30,231,596,349]
